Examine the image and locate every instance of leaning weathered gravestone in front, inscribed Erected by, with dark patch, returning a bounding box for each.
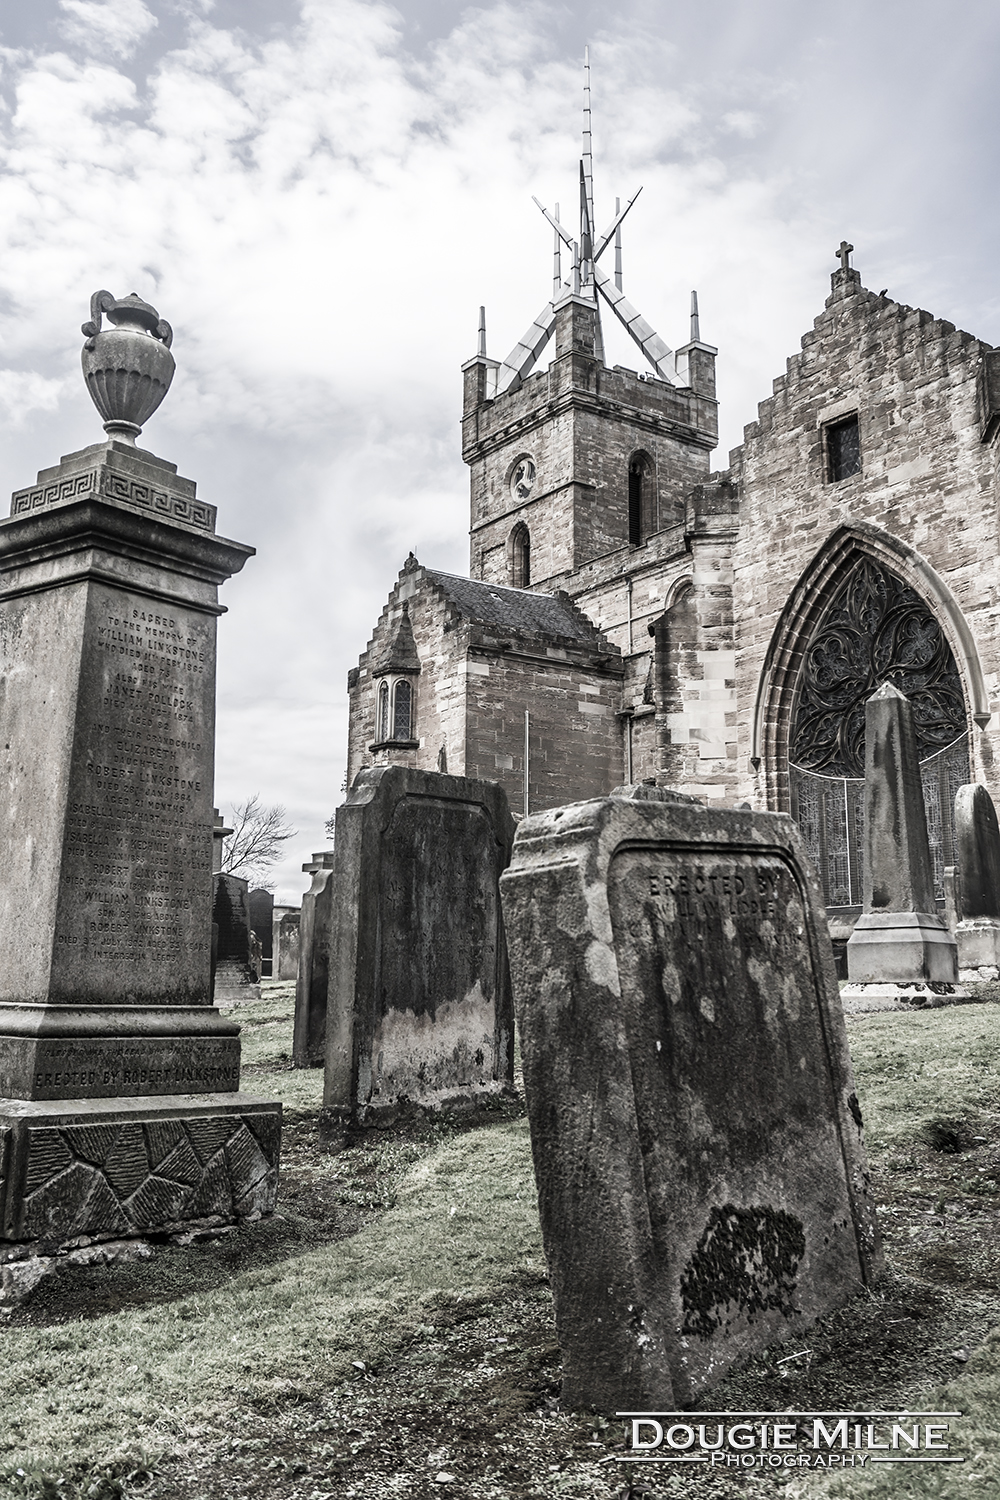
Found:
[501,797,880,1412]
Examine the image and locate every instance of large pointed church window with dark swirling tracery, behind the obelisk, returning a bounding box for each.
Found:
[789,558,970,906]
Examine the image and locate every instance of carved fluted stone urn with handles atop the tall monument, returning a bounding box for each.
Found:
[81,291,174,446]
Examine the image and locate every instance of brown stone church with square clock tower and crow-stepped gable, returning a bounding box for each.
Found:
[348,64,1000,921]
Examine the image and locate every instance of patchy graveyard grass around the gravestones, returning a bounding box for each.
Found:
[0,984,1000,1500]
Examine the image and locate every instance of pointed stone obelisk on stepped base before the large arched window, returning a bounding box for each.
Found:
[844,683,966,1010]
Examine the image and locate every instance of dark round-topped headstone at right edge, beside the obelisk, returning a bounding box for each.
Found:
[954,783,1000,980]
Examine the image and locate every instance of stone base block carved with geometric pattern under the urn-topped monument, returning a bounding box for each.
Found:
[0,1094,282,1250]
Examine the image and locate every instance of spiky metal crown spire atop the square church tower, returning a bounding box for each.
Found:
[496,47,697,395]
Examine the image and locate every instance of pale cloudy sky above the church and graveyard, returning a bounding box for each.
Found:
[0,0,1000,900]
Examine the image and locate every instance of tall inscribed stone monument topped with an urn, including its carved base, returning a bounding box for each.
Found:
[0,293,280,1251]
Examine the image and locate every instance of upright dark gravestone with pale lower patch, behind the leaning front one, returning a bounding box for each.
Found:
[324,767,514,1124]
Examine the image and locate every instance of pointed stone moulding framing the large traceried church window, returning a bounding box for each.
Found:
[750,522,991,812]
